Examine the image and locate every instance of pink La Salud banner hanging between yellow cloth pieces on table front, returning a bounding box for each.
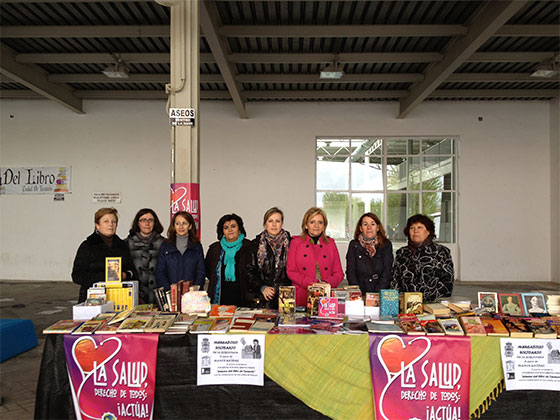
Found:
[369,334,471,420]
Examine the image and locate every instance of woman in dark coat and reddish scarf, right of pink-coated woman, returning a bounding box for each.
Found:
[346,213,393,294]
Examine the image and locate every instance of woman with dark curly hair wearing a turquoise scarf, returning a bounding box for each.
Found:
[206,213,251,306]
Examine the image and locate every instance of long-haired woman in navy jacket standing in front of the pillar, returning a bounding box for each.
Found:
[156,211,206,290]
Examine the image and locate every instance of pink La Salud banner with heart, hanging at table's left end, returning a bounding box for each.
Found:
[64,334,159,420]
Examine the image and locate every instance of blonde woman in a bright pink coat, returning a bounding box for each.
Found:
[286,207,344,306]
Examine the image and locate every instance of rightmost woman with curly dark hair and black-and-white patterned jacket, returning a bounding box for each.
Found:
[391,214,454,302]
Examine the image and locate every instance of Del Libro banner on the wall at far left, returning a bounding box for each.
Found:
[0,166,72,195]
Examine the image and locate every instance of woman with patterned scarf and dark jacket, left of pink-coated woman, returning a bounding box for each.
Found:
[247,207,292,309]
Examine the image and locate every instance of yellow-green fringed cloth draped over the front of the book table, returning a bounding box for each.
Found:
[264,334,503,419]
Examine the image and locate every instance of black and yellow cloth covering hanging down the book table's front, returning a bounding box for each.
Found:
[35,334,560,420]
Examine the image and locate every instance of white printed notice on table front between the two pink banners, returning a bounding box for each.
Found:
[196,334,265,386]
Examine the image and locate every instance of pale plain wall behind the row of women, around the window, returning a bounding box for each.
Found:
[0,100,558,281]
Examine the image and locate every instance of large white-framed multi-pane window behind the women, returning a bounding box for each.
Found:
[316,137,457,243]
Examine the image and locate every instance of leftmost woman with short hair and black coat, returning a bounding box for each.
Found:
[72,207,138,303]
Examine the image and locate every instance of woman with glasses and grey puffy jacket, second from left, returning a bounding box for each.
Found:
[126,209,165,303]
